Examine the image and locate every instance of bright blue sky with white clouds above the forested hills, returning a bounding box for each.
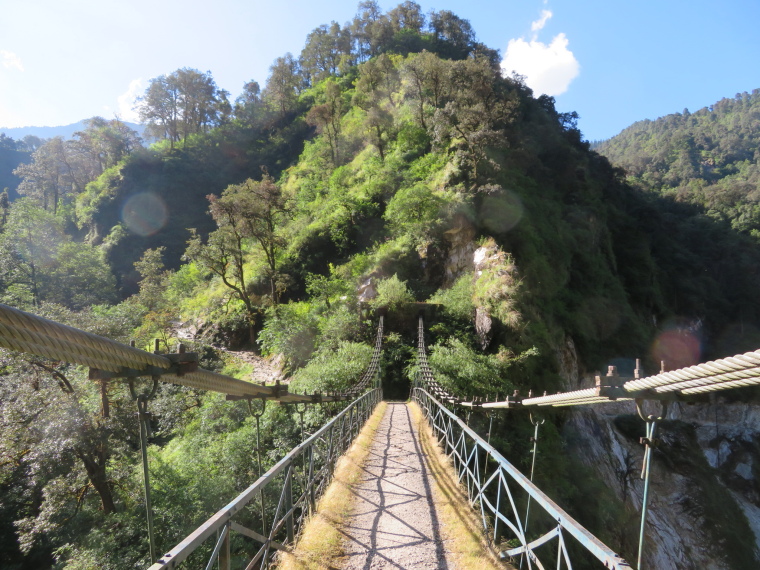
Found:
[0,0,760,140]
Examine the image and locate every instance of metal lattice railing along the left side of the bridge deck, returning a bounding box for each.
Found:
[150,388,382,570]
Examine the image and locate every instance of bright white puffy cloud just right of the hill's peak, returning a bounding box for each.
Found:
[501,10,581,96]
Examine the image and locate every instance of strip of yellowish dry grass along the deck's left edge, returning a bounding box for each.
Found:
[277,402,388,570]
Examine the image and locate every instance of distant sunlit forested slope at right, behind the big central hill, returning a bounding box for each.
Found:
[597,89,760,238]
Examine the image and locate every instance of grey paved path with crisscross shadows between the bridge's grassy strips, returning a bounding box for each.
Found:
[343,402,455,570]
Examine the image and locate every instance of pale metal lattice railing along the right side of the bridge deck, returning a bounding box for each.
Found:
[412,387,631,570]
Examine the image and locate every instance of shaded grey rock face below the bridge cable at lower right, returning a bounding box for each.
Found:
[565,402,760,570]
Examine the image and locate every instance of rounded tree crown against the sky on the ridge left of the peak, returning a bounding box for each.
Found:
[138,67,227,148]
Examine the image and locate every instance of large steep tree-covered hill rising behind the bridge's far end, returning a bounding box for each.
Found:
[0,1,760,569]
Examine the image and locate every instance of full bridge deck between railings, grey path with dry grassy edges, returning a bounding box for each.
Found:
[283,402,506,570]
